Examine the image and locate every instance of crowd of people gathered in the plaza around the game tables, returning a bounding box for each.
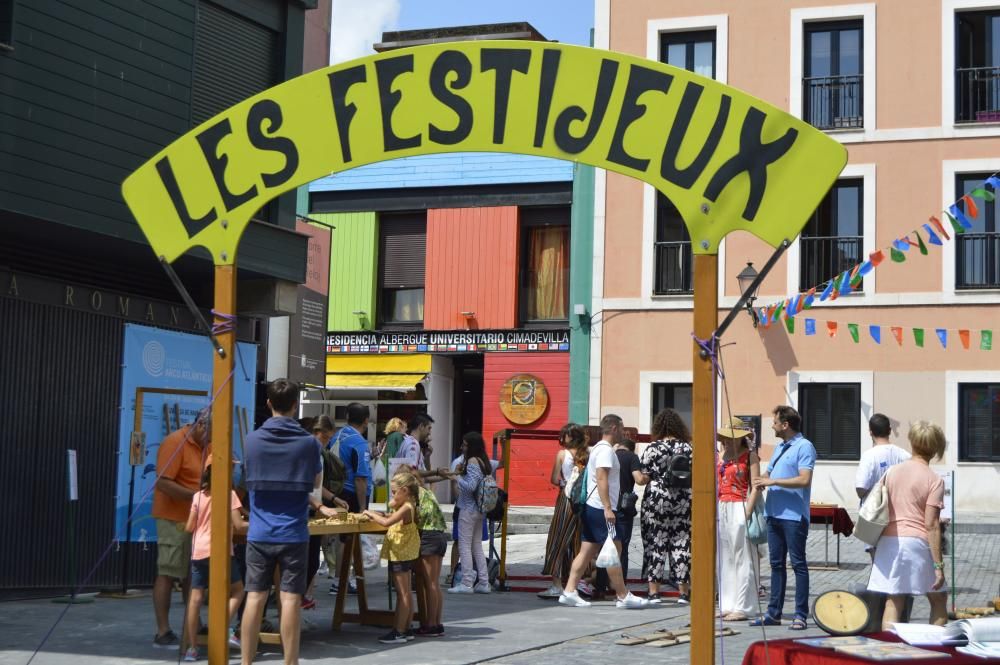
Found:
[153,379,946,665]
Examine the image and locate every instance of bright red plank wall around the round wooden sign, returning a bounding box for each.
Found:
[483,353,569,506]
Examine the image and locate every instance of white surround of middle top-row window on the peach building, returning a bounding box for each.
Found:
[788,4,878,143]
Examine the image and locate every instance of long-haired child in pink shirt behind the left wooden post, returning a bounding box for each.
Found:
[184,466,248,662]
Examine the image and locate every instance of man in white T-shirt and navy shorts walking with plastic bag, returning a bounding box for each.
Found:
[559,413,648,609]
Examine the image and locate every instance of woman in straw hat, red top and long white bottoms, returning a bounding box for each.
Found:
[718,417,760,621]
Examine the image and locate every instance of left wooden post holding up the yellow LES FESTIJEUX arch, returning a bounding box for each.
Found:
[208,265,236,665]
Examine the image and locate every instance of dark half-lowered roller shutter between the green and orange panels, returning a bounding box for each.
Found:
[379,212,427,289]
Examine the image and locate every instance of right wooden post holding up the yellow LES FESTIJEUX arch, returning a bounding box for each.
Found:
[691,254,719,665]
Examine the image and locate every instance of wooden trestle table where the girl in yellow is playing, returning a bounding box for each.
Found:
[254,520,426,644]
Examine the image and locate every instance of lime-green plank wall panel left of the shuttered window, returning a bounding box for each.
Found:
[309,212,378,330]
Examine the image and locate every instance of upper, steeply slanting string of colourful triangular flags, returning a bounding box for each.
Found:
[755,173,1000,329]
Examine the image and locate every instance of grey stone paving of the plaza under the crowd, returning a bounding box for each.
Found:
[0,529,1000,665]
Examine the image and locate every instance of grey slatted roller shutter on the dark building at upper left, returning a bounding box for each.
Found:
[191,0,279,126]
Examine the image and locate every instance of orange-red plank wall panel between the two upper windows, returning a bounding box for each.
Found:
[424,206,518,330]
